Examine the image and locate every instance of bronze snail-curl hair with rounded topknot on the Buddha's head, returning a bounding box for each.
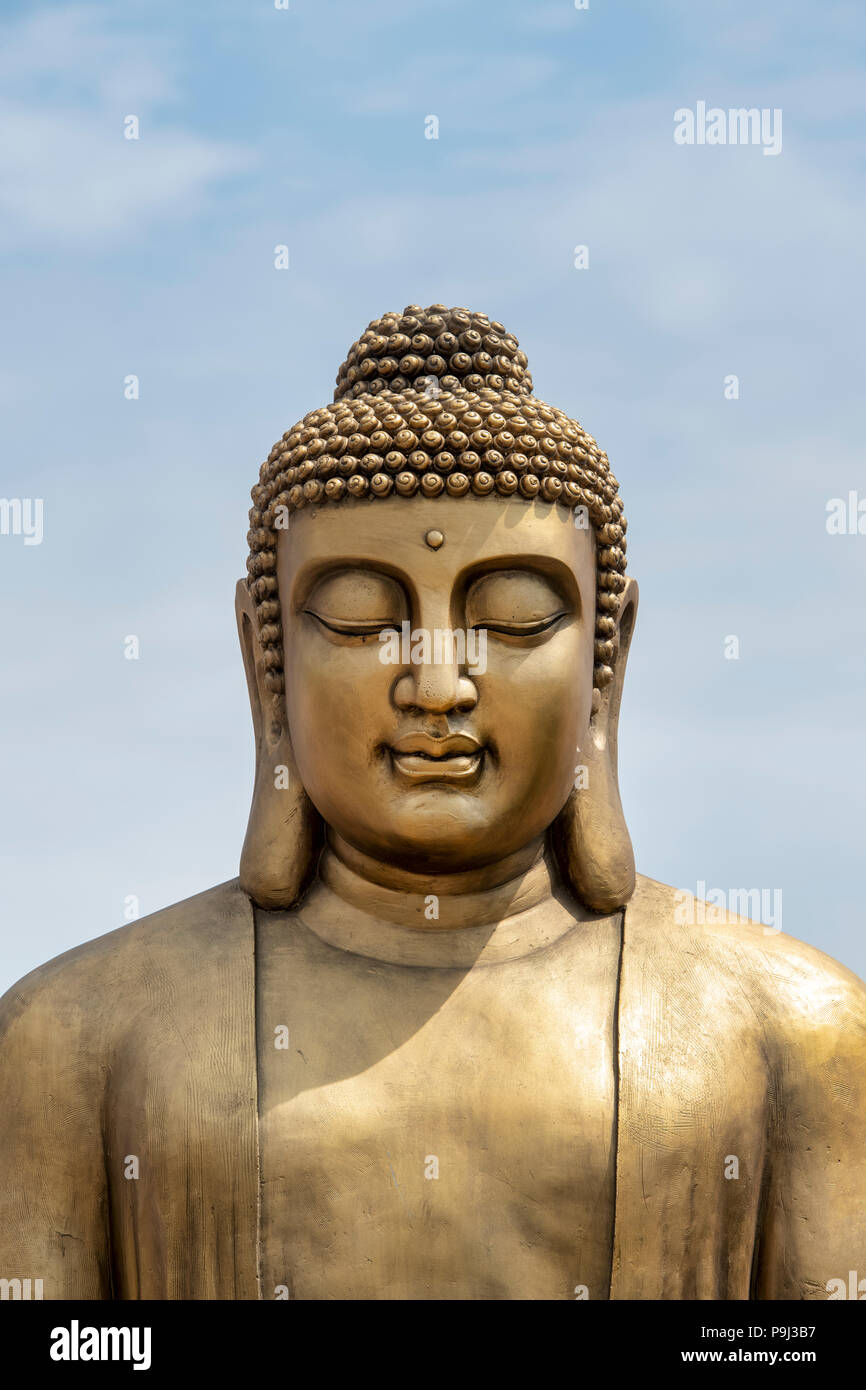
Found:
[246,304,626,711]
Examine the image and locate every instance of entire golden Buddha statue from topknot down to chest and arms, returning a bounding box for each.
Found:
[0,304,866,1300]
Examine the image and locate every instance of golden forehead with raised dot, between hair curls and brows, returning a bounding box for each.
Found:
[277,496,595,596]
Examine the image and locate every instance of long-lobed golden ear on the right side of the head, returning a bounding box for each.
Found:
[552,578,638,912]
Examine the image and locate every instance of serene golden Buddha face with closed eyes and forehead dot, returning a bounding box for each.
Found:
[277,498,595,873]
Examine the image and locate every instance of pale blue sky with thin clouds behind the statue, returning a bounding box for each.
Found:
[0,0,866,988]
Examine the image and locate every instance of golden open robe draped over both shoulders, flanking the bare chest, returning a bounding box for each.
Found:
[0,877,866,1300]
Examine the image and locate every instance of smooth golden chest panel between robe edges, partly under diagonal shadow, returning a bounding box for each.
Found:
[257,937,617,1300]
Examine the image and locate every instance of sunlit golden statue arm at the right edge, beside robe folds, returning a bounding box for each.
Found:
[753,958,866,1300]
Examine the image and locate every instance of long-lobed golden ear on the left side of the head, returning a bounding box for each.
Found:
[235,580,322,909]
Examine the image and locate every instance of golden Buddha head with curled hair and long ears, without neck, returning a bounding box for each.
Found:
[238,304,637,912]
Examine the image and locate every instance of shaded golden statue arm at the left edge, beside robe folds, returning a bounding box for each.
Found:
[0,962,111,1300]
